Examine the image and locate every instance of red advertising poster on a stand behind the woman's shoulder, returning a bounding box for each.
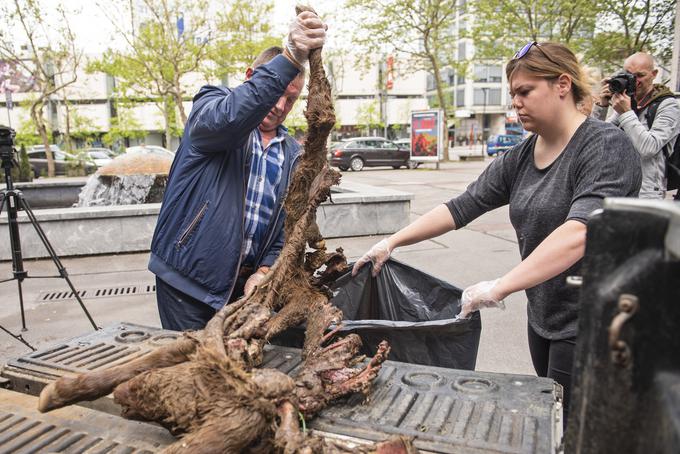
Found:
[411,110,444,161]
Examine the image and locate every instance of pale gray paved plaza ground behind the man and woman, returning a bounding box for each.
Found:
[0,159,533,374]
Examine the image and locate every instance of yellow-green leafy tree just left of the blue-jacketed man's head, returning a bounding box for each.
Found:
[88,0,211,144]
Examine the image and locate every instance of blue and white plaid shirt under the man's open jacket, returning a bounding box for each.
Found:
[243,126,288,266]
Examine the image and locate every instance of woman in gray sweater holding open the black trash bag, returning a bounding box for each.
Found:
[354,42,641,420]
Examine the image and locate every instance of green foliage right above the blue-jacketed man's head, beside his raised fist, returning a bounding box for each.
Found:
[209,0,281,79]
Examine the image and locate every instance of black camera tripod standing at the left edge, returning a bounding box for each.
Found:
[0,148,99,351]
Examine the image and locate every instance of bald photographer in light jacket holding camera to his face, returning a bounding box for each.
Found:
[592,52,680,199]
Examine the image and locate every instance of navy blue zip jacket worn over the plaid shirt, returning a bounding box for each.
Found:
[149,55,300,309]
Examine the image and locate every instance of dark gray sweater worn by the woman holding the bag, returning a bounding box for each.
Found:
[446,118,641,339]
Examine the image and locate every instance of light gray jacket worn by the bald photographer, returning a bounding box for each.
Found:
[592,98,680,199]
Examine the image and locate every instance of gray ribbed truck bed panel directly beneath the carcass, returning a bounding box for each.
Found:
[1,323,562,454]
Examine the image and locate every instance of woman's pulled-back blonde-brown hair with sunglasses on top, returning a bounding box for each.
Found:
[505,42,591,104]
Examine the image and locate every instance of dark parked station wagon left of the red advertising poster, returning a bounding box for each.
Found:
[328,137,414,172]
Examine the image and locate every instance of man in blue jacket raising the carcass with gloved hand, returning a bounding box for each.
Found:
[149,12,325,331]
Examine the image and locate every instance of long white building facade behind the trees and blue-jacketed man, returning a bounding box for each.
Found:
[0,55,427,150]
